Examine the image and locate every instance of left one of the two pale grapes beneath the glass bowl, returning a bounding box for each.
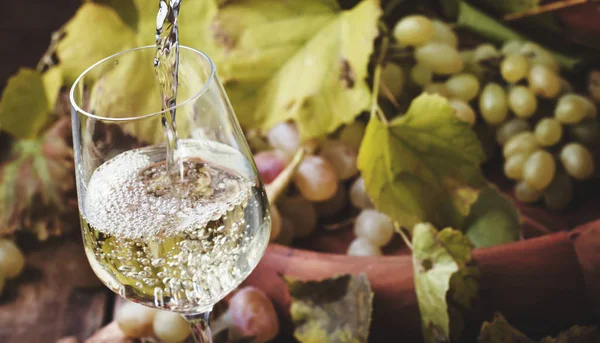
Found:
[115,301,157,338]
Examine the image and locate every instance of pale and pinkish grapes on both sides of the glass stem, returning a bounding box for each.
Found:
[115,287,279,343]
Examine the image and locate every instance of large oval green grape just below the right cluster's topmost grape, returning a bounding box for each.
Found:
[415,42,463,75]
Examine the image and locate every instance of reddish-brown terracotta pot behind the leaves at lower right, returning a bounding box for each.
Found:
[246,221,600,342]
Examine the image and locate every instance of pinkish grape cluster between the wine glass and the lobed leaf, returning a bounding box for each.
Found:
[254,120,394,256]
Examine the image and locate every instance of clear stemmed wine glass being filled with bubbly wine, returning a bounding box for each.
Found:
[70,46,271,342]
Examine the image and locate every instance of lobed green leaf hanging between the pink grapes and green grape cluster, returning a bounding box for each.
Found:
[358,94,485,228]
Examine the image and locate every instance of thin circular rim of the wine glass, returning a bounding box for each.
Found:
[69,45,216,122]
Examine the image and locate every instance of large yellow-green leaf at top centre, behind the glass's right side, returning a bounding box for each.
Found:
[215,0,381,138]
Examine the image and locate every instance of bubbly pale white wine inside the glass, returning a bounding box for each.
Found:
[79,139,270,313]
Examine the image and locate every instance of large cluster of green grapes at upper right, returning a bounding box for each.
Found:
[381,15,600,209]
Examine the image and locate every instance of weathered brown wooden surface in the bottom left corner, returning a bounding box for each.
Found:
[0,238,112,343]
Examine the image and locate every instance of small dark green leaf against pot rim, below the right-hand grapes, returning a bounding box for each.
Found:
[465,187,521,248]
